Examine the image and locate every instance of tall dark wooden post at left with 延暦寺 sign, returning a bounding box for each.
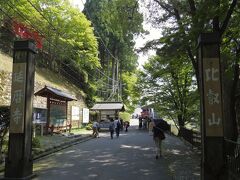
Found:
[5,41,36,179]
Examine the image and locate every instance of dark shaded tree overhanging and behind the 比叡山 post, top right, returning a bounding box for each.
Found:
[142,0,239,138]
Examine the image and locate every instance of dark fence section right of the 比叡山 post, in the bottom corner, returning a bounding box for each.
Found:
[224,138,240,180]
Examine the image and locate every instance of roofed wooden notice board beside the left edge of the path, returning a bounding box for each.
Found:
[35,86,77,133]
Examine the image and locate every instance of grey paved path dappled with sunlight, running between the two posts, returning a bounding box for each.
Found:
[31,121,200,180]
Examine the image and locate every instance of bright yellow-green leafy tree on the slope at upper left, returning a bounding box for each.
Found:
[0,0,101,103]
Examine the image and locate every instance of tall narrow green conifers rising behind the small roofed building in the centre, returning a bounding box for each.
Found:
[84,0,143,106]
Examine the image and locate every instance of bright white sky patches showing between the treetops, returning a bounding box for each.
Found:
[70,0,161,69]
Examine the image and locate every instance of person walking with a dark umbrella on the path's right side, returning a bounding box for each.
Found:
[153,123,165,159]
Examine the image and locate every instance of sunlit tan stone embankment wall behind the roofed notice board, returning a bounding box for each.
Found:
[0,52,86,125]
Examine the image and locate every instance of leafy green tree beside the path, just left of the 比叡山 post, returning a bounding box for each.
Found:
[139,52,199,130]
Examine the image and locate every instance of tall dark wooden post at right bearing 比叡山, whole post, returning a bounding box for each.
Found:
[199,33,226,180]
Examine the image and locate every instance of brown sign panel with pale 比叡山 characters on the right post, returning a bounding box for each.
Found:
[203,58,223,136]
